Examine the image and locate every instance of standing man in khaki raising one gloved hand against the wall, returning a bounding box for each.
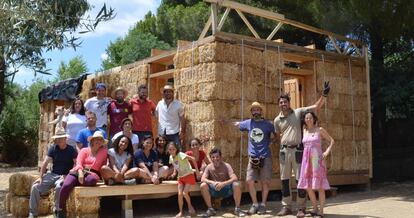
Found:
[274,82,330,217]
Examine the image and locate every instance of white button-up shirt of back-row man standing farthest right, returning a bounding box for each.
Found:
[155,99,184,135]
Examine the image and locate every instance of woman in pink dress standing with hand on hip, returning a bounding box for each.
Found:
[298,111,334,217]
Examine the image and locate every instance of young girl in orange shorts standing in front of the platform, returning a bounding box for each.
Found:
[168,142,199,217]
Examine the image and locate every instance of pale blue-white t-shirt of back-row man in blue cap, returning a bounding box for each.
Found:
[85,96,111,127]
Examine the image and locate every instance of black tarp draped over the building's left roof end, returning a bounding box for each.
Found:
[39,74,88,104]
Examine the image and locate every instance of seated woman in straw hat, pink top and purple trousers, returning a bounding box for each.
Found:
[57,131,108,217]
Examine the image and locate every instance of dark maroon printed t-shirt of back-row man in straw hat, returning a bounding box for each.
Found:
[107,101,132,136]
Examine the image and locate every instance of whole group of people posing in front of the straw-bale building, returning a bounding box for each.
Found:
[30,83,333,217]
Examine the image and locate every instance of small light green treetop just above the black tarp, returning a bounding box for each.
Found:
[57,56,88,81]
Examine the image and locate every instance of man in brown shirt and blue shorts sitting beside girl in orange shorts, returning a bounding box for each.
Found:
[200,148,246,217]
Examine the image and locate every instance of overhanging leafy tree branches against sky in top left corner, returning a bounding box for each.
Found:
[0,0,114,113]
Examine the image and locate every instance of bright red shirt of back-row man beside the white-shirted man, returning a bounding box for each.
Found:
[129,98,156,132]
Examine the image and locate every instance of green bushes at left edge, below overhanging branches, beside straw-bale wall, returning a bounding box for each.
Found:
[0,80,47,166]
